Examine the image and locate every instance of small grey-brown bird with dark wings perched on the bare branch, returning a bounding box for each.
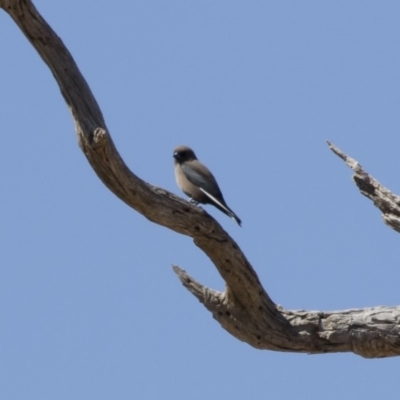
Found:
[174,146,242,226]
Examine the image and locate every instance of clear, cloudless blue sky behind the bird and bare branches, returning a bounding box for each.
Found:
[0,0,400,400]
